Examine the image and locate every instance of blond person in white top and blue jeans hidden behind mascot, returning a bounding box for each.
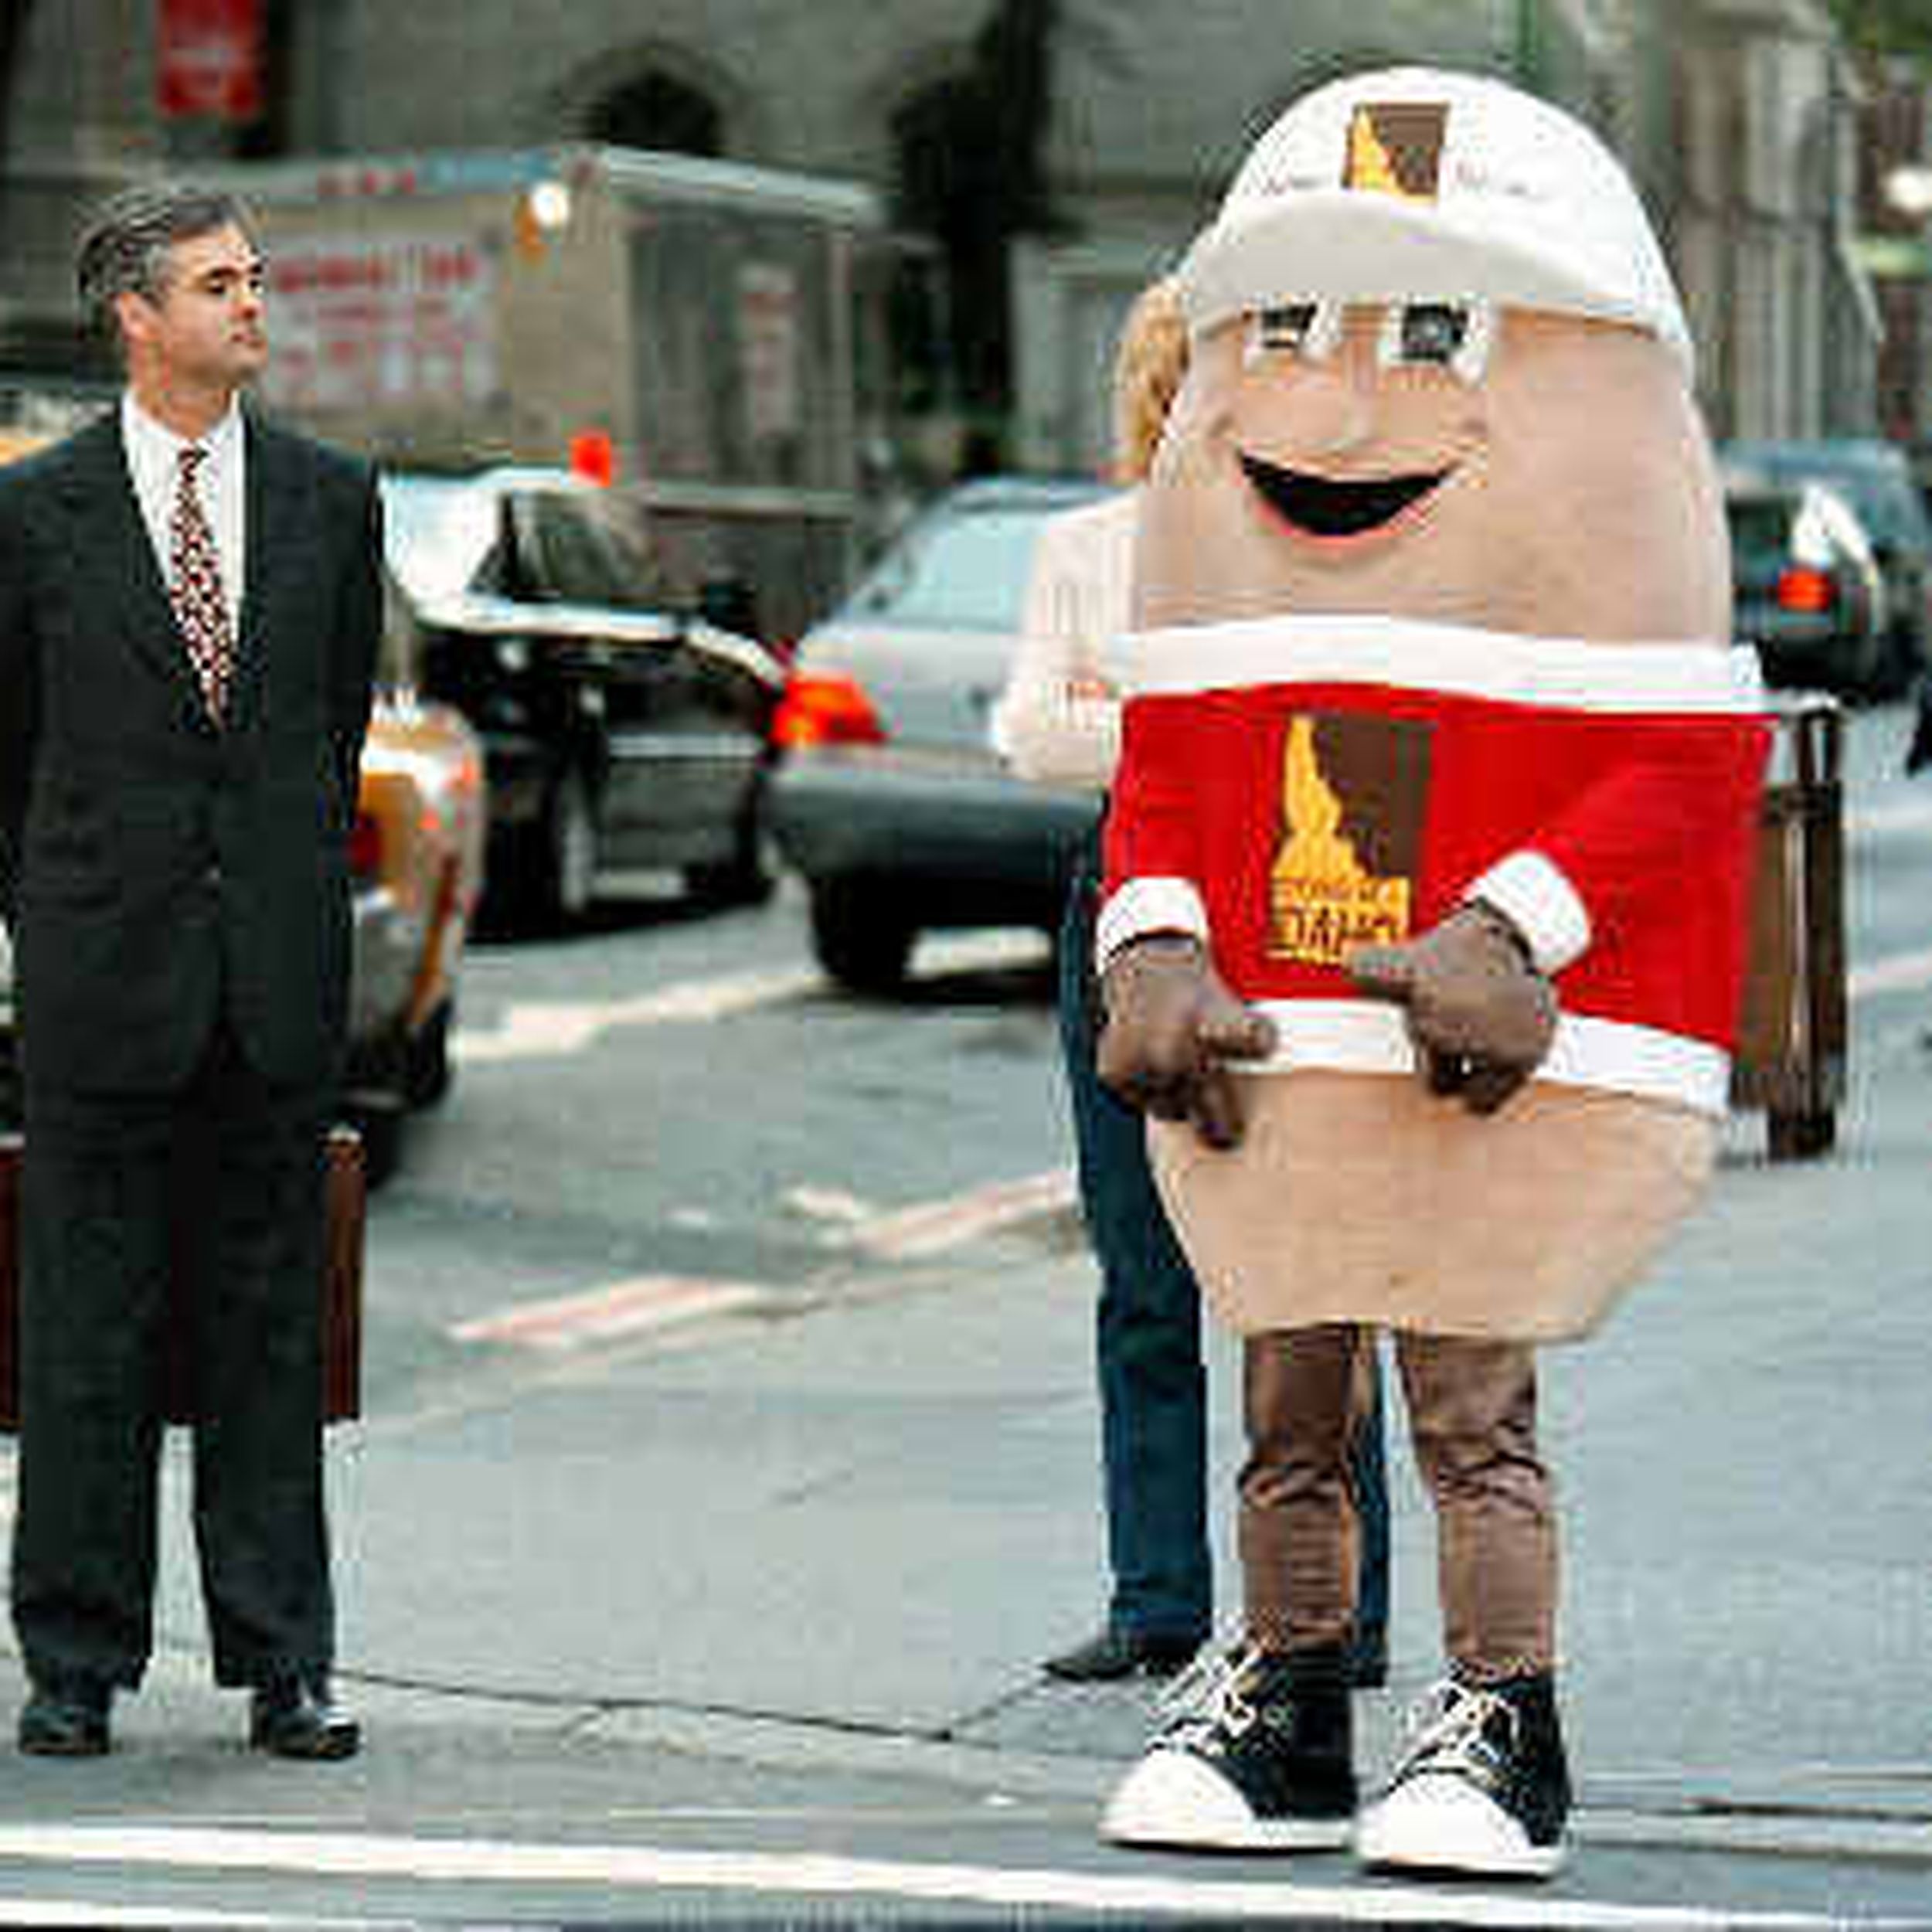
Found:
[993,282,1389,1685]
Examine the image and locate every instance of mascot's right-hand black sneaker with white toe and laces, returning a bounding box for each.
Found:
[1355,1677,1571,1878]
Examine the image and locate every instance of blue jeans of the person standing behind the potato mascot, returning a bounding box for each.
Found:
[1059,856,1389,1654]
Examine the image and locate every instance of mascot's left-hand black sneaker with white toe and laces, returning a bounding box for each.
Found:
[1100,1646,1355,1851]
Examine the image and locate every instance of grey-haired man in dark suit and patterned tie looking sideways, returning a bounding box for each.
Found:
[0,185,381,1758]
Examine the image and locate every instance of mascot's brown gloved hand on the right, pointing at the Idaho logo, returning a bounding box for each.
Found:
[1345,903,1557,1113]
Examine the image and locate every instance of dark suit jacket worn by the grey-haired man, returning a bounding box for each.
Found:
[0,412,381,1105]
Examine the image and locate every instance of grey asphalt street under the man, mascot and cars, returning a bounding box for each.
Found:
[0,692,1932,1927]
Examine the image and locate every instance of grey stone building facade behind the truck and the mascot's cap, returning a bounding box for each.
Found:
[0,0,1917,470]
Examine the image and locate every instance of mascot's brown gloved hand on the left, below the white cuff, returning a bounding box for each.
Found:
[1097,934,1275,1148]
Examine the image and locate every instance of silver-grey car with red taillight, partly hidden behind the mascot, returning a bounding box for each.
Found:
[771,478,1104,993]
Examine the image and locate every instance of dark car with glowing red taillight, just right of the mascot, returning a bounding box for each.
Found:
[1723,462,1892,698]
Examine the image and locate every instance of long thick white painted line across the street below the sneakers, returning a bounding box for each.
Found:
[0,1824,1882,1932]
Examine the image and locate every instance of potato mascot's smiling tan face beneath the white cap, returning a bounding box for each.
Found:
[1138,301,1730,640]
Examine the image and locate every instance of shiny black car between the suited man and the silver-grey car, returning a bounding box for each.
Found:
[383,470,784,923]
